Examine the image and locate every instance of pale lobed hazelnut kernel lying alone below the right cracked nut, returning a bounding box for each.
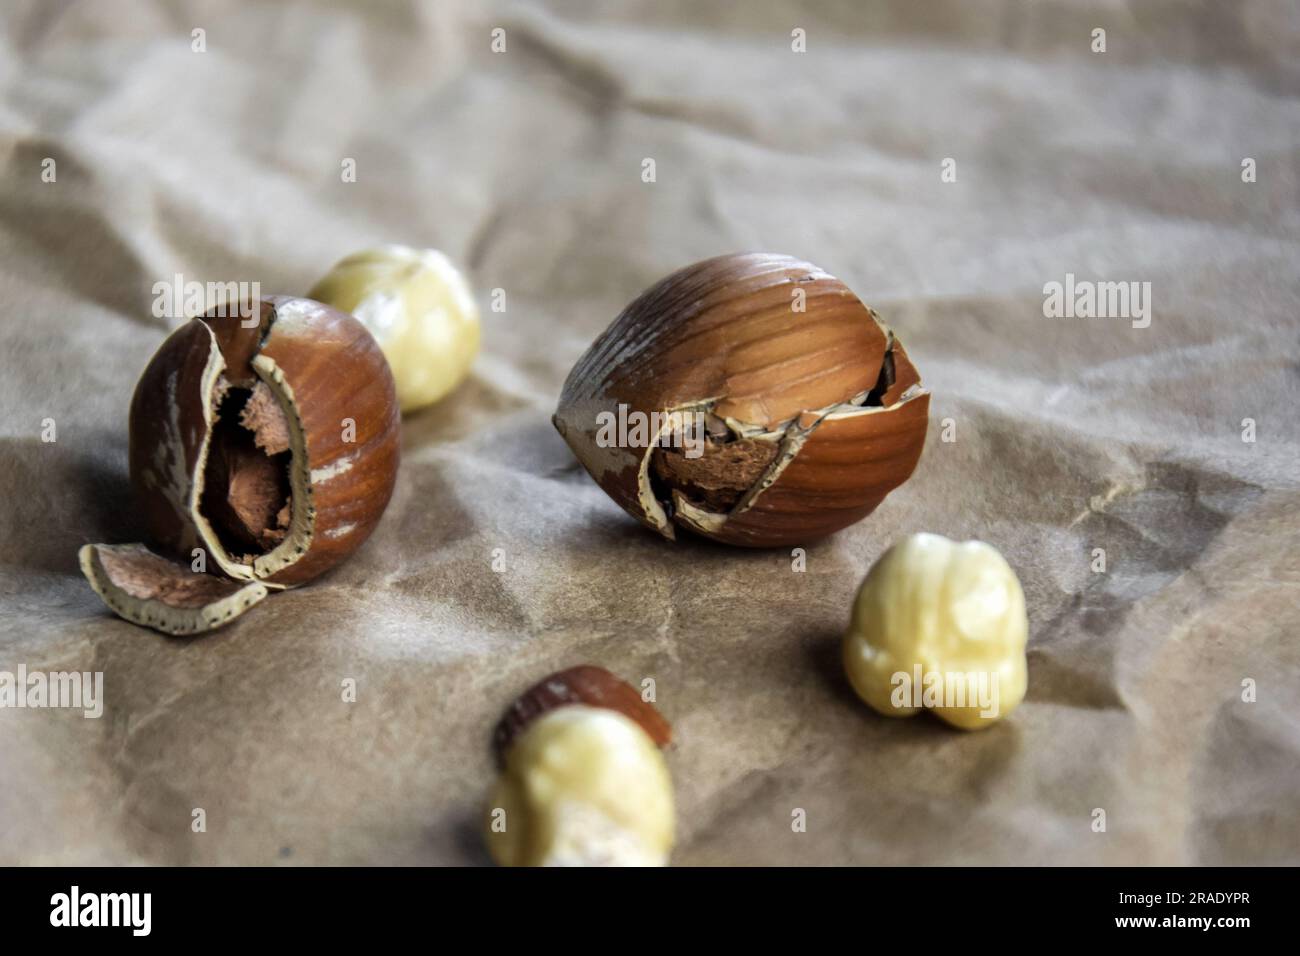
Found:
[844,533,1030,730]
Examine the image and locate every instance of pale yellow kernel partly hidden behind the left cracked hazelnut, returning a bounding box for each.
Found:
[308,246,480,412]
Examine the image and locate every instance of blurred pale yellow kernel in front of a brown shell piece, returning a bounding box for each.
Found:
[485,705,675,866]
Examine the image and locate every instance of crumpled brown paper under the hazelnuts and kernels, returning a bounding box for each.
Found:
[0,0,1300,865]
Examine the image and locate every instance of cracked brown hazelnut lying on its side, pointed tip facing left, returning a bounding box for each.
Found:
[554,254,930,548]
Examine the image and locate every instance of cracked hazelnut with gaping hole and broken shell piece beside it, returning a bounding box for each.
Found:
[81,297,399,633]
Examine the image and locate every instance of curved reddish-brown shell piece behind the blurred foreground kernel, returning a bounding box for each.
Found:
[493,665,672,762]
